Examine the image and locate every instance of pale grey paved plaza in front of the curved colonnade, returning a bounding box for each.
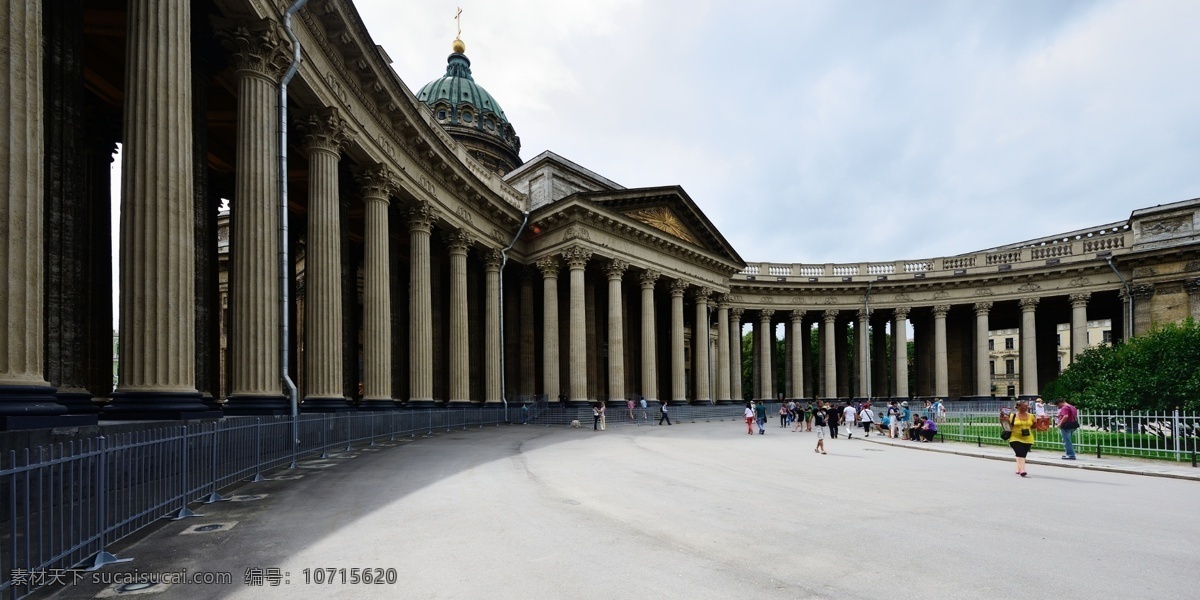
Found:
[44,421,1200,600]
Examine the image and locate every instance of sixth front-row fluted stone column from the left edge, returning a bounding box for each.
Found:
[408,202,438,407]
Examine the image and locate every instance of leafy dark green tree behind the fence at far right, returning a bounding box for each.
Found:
[1045,319,1200,410]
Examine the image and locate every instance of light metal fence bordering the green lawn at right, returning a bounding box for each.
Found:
[937,407,1200,466]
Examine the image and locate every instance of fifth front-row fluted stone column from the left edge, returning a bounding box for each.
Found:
[356,166,396,408]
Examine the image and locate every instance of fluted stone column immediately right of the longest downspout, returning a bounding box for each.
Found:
[298,110,349,410]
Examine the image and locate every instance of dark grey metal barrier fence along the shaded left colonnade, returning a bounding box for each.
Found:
[0,407,520,599]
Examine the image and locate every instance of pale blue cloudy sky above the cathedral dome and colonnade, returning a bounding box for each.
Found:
[355,0,1200,263]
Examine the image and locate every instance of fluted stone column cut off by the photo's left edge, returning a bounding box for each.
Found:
[0,0,65,424]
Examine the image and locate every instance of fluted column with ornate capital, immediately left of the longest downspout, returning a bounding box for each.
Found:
[220,20,292,415]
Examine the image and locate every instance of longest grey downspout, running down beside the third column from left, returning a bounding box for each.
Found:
[280,0,308,469]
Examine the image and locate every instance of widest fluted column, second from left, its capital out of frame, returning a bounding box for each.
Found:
[108,0,205,419]
